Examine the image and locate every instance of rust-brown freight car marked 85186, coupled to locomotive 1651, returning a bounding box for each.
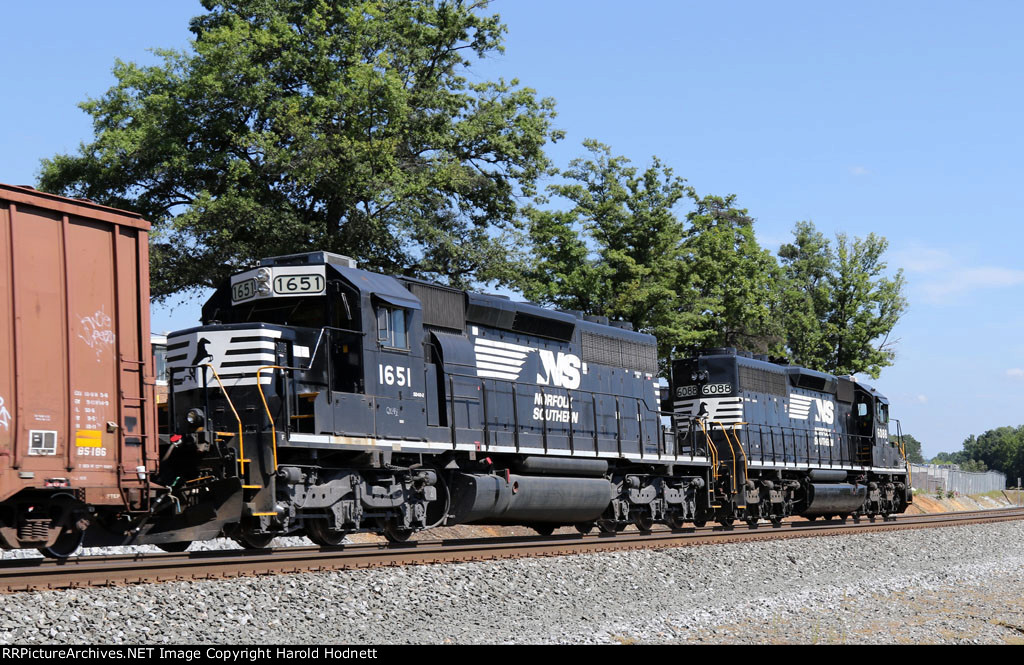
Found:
[0,184,158,554]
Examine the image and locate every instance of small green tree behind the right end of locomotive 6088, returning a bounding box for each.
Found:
[778,221,906,378]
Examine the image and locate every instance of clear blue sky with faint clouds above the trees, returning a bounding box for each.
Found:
[0,0,1024,456]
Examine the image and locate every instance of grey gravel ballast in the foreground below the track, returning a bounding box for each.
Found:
[0,522,1024,645]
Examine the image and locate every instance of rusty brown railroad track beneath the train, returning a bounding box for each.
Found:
[0,508,1024,593]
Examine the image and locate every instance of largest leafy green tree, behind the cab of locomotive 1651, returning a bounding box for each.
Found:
[39,0,561,296]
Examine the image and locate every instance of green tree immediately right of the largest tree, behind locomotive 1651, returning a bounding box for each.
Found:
[521,139,696,358]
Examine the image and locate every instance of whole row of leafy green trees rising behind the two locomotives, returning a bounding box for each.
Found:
[39,0,906,377]
